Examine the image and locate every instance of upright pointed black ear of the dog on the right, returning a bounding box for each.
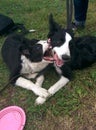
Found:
[48,14,61,38]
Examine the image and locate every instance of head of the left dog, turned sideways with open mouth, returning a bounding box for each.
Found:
[22,39,52,63]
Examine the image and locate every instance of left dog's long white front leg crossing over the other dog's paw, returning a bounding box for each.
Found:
[15,77,48,98]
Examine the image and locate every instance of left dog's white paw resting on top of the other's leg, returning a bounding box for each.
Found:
[34,87,49,98]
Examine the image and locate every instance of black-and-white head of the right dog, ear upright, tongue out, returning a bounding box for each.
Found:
[48,15,72,67]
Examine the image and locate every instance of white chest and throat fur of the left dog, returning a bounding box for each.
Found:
[21,55,48,74]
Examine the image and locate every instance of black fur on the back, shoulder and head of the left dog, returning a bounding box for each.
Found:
[2,34,43,83]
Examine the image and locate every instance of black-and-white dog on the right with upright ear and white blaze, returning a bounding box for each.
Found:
[36,15,96,104]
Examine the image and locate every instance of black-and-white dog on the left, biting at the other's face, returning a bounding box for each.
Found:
[2,34,52,97]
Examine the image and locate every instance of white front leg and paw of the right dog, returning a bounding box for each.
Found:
[35,76,69,105]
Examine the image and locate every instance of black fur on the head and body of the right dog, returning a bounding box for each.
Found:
[48,15,96,79]
